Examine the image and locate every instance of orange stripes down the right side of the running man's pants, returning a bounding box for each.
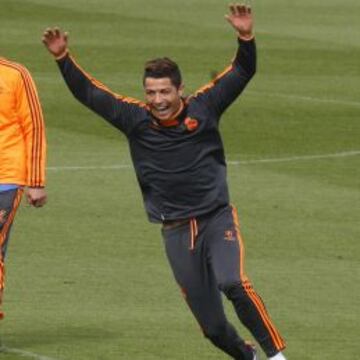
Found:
[232,206,285,351]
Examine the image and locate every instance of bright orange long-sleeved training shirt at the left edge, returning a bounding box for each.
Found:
[0,58,46,187]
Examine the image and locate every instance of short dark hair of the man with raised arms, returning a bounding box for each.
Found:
[143,57,182,89]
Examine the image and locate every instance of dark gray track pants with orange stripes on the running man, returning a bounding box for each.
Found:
[162,206,285,360]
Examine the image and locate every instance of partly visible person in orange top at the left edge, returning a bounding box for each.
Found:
[0,57,47,319]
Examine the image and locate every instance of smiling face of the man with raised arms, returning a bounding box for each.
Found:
[144,77,183,121]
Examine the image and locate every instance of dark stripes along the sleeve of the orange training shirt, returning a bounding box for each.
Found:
[1,60,44,186]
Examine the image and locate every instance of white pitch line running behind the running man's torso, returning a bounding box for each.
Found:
[47,150,360,171]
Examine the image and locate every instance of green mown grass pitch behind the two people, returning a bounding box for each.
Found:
[0,0,360,360]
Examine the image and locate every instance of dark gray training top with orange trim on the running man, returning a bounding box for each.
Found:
[57,40,256,222]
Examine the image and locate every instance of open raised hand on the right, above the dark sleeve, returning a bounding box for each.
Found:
[225,4,253,39]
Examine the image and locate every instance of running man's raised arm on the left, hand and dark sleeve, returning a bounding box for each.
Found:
[43,29,146,134]
